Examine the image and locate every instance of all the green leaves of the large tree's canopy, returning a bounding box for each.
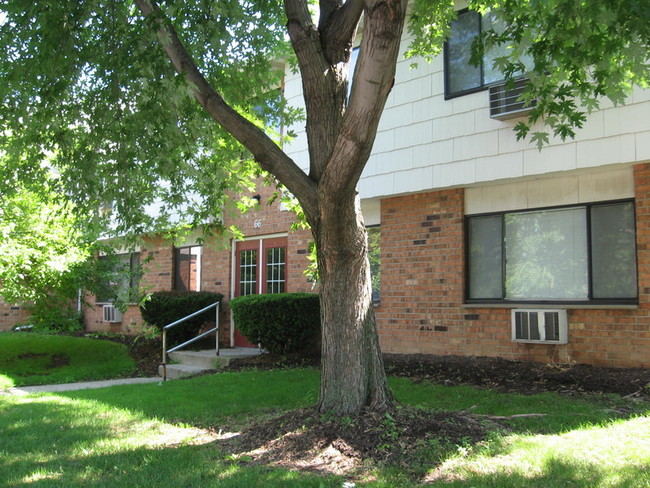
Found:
[0,0,650,233]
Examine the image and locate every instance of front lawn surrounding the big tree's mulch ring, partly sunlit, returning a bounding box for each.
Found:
[0,368,650,488]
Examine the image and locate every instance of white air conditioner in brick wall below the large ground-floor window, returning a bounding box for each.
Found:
[512,309,568,344]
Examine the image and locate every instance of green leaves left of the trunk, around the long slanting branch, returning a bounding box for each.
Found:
[0,0,299,235]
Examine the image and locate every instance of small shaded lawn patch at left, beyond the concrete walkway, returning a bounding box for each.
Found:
[0,332,135,390]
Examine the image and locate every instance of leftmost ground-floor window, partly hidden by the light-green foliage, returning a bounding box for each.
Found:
[96,252,141,303]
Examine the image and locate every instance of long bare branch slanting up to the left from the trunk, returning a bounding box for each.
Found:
[135,0,317,215]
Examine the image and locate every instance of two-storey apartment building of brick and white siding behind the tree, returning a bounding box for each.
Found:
[2,2,650,368]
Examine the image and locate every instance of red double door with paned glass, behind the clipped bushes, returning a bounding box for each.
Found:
[234,237,287,347]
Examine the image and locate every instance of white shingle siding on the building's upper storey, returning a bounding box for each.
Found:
[286,28,650,201]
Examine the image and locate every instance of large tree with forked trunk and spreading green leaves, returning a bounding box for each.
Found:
[0,0,649,413]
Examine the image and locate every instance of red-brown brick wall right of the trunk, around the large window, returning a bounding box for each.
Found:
[377,164,650,368]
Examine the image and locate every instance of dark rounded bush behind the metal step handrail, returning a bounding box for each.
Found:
[140,291,223,345]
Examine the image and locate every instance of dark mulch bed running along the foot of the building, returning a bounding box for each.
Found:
[98,336,650,399]
